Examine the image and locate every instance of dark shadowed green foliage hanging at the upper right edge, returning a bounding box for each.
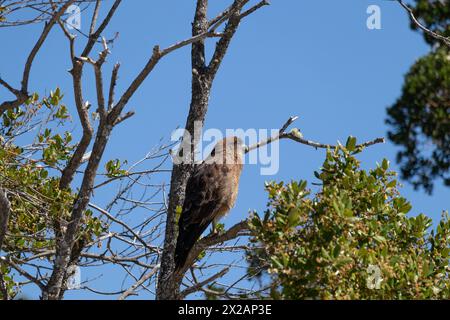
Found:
[386,0,450,193]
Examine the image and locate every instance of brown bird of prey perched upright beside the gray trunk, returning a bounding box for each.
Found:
[175,137,245,270]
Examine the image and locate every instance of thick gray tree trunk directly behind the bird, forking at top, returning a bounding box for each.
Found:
[156,0,256,300]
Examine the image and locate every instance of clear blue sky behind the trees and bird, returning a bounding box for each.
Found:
[0,0,450,298]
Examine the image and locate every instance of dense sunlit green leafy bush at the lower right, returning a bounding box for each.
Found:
[249,139,450,299]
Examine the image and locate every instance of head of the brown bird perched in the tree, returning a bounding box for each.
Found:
[205,136,245,164]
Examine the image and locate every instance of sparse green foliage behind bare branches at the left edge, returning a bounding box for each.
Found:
[0,89,104,298]
